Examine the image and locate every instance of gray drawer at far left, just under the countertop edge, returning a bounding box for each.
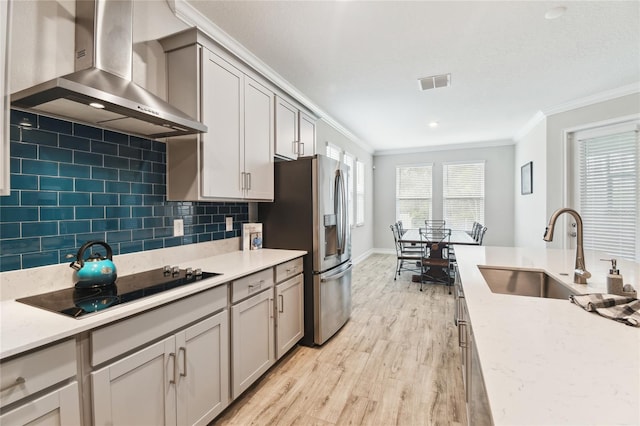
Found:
[0,340,77,406]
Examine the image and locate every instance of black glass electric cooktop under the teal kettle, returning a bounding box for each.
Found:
[16,267,221,318]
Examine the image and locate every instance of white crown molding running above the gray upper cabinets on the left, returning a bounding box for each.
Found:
[166,0,374,154]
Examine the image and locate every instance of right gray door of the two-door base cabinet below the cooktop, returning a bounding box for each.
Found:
[176,310,229,425]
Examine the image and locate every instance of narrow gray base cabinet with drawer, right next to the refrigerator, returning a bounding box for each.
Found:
[275,258,304,359]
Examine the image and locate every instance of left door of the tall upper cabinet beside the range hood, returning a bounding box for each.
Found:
[200,49,244,198]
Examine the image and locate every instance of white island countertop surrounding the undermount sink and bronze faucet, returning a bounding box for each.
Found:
[456,246,640,425]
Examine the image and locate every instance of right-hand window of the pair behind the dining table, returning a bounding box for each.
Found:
[442,162,484,229]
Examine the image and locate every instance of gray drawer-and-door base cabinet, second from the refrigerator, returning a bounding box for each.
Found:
[231,268,275,399]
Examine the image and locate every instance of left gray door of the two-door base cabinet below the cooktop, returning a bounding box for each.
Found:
[91,336,178,426]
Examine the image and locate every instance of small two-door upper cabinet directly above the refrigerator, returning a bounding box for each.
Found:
[275,97,316,159]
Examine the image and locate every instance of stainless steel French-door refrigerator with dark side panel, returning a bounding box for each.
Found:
[258,155,352,346]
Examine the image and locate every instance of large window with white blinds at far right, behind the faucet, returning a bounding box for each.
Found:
[574,123,640,260]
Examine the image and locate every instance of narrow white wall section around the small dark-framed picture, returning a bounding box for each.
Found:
[513,118,548,247]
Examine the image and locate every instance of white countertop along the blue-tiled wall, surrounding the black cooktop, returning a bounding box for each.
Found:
[0,249,306,359]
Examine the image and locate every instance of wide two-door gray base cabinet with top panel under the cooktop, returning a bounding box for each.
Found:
[91,285,229,426]
